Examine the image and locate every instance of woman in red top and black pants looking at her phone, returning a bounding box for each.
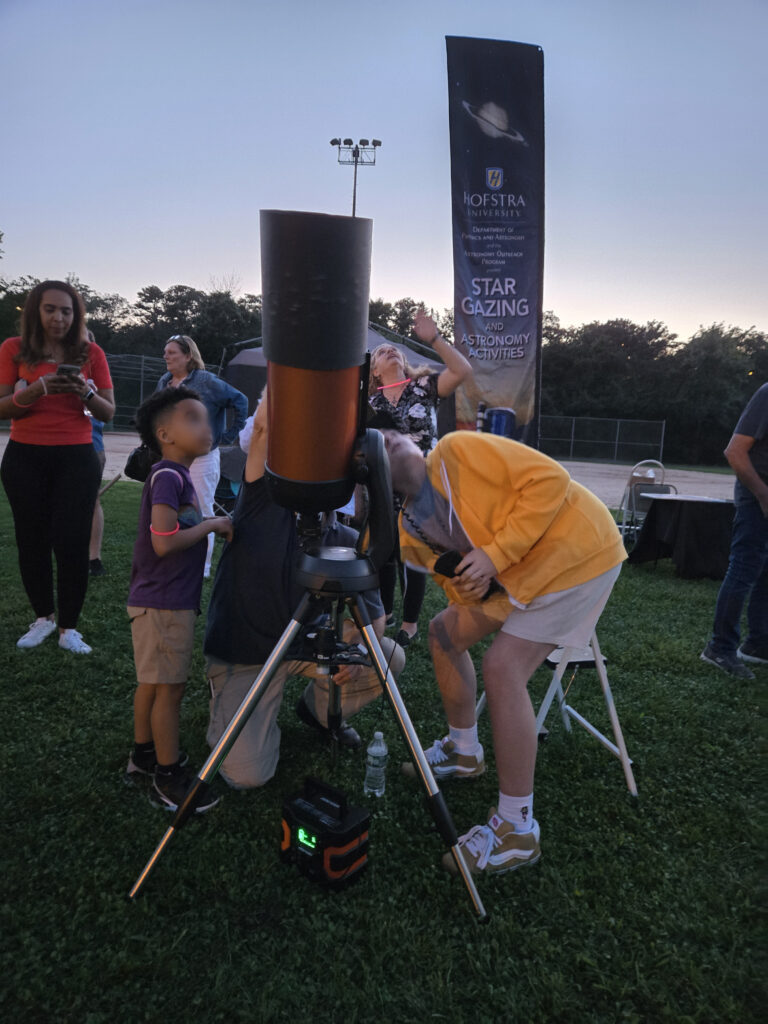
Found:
[0,281,115,654]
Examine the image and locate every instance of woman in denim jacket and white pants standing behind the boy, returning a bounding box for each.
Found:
[156,334,248,579]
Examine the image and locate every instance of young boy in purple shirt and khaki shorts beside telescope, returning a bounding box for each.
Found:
[127,387,232,813]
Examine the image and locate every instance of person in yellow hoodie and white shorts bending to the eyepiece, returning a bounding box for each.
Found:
[382,423,626,873]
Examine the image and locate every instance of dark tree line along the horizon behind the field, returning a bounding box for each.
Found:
[0,275,768,464]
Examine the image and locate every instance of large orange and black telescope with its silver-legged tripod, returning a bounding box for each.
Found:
[129,210,486,921]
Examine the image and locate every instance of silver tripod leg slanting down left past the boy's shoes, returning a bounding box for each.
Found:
[128,594,311,899]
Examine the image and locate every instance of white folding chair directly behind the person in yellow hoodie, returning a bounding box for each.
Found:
[475,633,637,797]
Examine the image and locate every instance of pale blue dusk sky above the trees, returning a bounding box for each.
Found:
[0,0,768,338]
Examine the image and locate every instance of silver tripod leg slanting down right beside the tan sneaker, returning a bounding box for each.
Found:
[351,598,488,923]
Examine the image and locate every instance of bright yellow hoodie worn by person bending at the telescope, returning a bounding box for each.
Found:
[399,430,627,604]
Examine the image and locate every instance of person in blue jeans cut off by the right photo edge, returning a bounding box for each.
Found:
[701,384,768,679]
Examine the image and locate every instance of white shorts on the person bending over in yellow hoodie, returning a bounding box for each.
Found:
[501,563,622,647]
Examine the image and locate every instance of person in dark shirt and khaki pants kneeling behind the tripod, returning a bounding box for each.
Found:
[204,392,406,788]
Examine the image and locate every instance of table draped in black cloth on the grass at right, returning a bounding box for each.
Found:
[629,494,734,580]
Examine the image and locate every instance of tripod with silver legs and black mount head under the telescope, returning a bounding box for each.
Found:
[129,547,487,921]
